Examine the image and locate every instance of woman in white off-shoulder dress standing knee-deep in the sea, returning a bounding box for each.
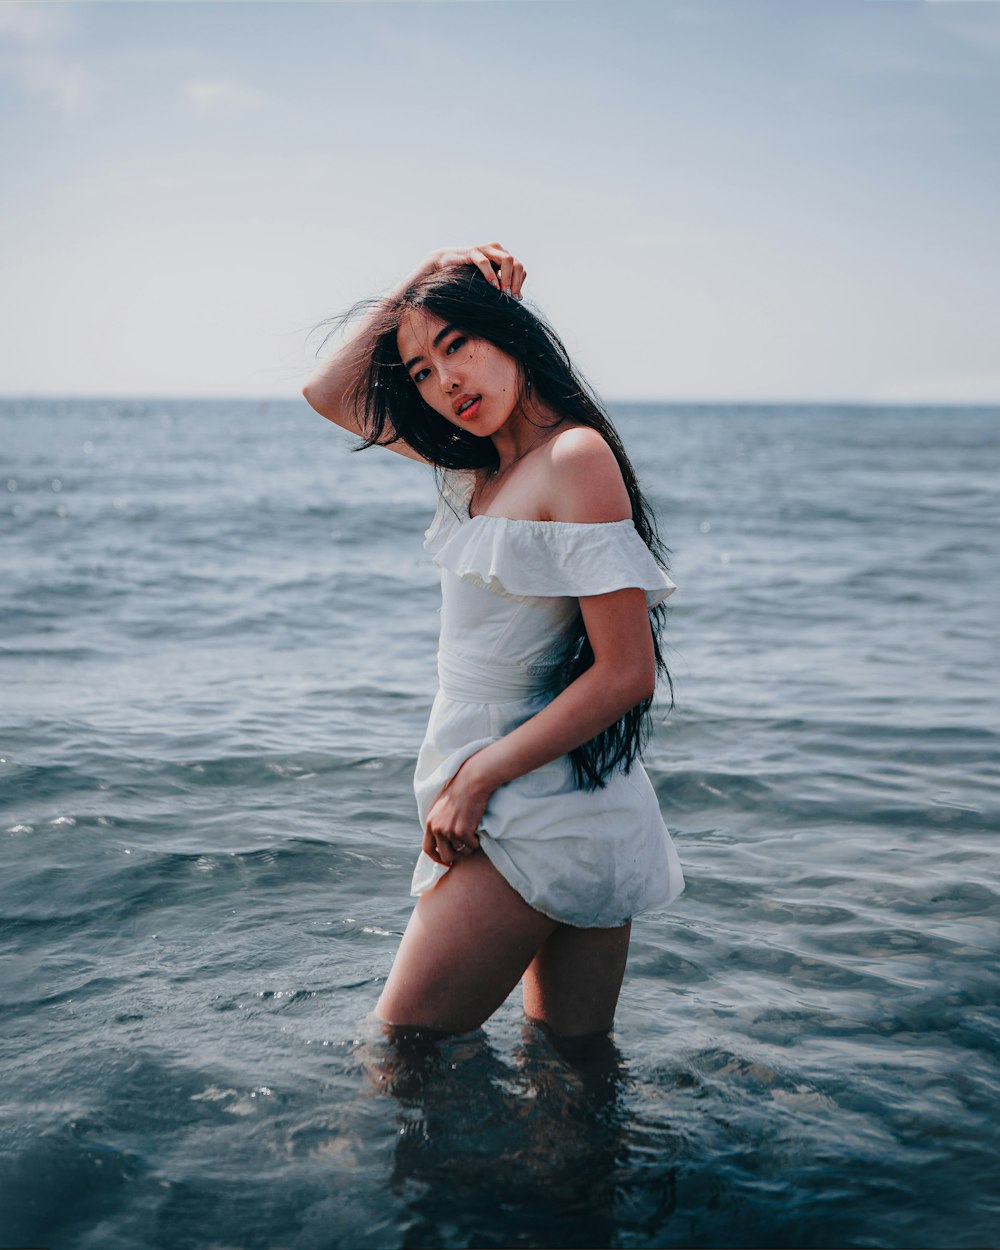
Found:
[304,244,684,1038]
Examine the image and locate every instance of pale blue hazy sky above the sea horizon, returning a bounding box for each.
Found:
[0,0,1000,404]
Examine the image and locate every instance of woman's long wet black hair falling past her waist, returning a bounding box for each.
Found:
[327,265,674,790]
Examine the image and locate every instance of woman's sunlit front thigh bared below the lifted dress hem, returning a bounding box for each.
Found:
[375,851,558,1033]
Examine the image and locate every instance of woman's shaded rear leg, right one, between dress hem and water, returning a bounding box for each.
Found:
[524,921,633,1038]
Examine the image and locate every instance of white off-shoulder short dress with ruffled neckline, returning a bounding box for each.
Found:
[410,470,684,928]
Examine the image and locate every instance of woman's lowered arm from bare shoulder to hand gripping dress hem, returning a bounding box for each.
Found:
[424,430,656,864]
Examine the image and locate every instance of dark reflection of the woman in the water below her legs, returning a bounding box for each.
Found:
[369,1021,629,1246]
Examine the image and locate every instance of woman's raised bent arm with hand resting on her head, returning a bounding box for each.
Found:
[303,243,525,464]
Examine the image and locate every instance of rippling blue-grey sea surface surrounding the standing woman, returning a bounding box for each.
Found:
[0,400,1000,1250]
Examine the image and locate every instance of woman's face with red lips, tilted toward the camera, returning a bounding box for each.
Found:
[396,309,520,438]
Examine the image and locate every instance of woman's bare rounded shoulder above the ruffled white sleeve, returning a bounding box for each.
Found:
[546,425,633,524]
